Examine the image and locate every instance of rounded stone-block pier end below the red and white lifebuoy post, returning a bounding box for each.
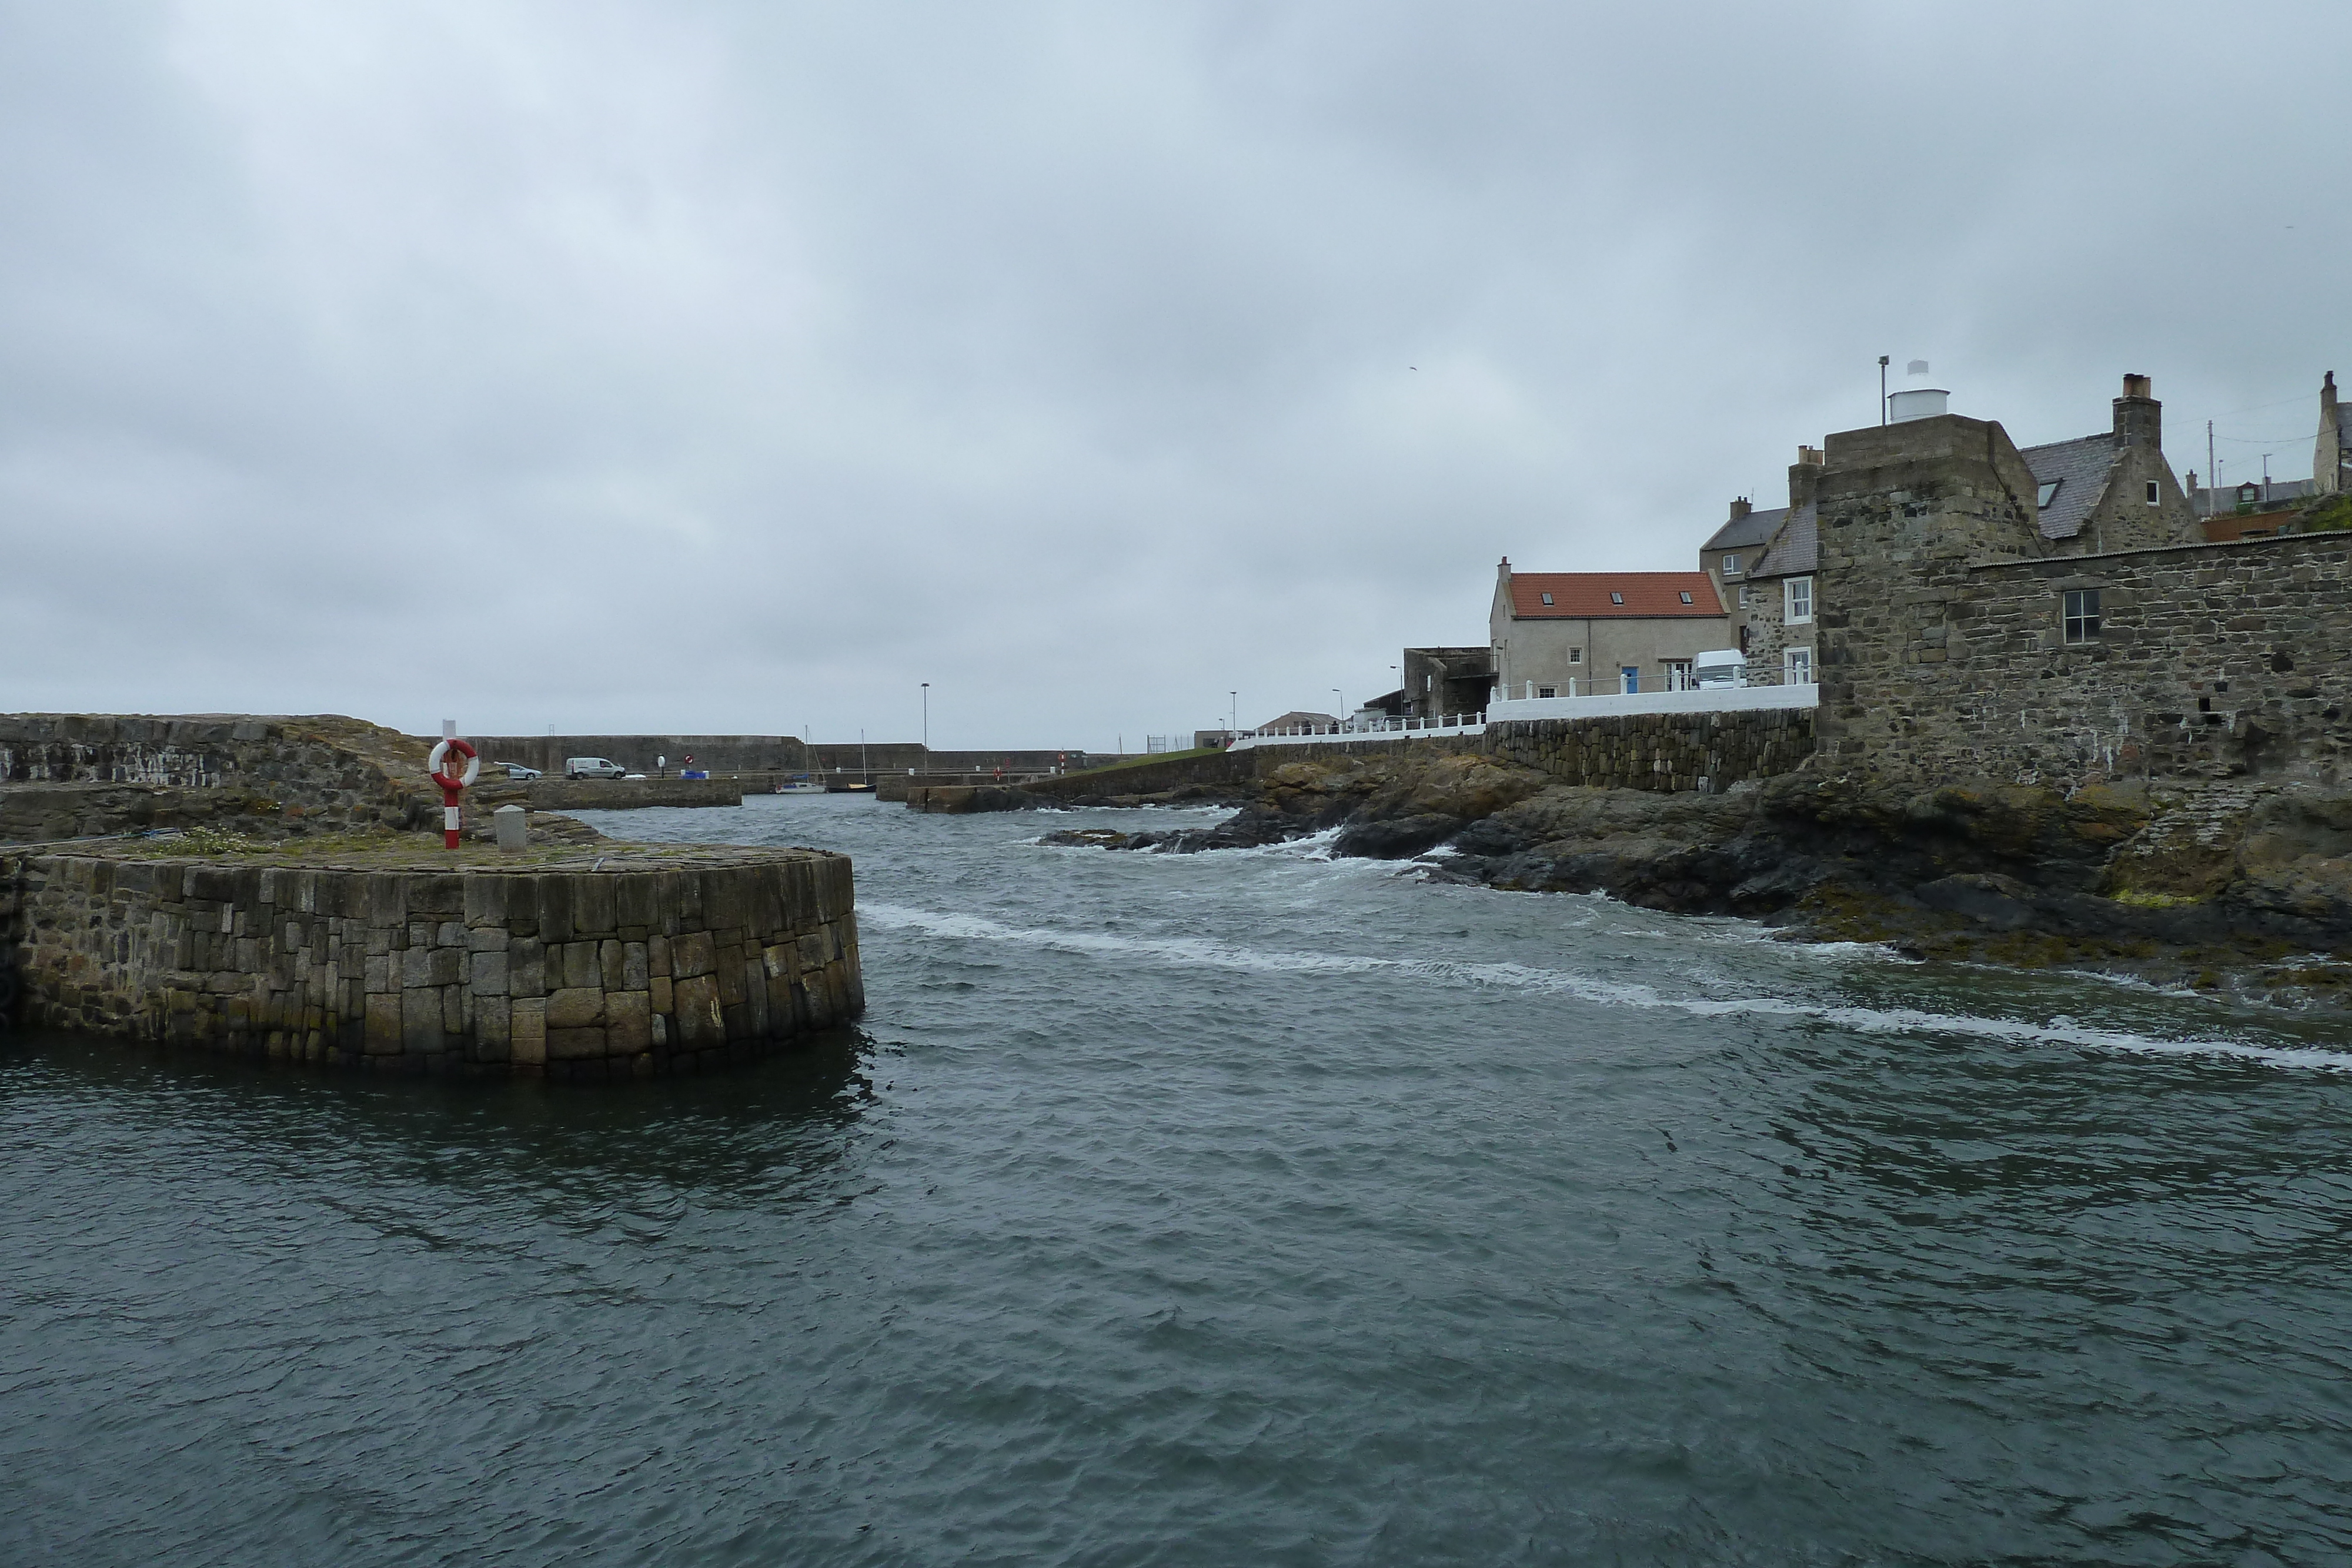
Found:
[0,846,866,1081]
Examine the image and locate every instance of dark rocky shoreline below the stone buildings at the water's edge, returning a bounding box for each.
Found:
[1047,755,2352,1008]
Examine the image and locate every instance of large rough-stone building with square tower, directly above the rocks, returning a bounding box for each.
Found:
[1813,409,2352,787]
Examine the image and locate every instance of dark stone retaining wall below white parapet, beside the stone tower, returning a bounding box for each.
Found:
[1482,708,1813,790]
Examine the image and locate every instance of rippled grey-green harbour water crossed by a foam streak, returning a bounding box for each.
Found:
[0,797,2352,1563]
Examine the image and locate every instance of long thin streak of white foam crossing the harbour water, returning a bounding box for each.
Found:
[858,902,2352,1072]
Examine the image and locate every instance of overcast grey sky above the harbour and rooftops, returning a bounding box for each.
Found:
[0,0,2352,750]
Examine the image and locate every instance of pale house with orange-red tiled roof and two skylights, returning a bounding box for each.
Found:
[1486,555,1731,696]
